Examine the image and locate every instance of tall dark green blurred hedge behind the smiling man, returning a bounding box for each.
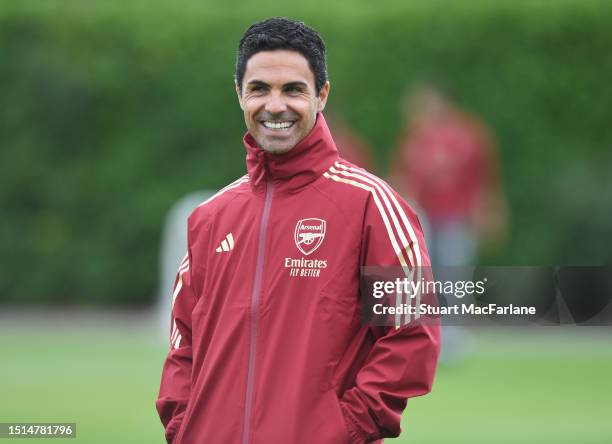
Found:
[0,0,612,304]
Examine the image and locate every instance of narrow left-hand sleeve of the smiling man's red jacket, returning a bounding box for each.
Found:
[155,248,195,444]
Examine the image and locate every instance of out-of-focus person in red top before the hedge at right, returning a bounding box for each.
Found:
[391,83,508,364]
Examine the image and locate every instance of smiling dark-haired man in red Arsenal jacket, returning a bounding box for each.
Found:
[157,19,439,444]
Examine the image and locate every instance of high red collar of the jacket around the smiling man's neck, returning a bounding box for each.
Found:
[244,113,338,193]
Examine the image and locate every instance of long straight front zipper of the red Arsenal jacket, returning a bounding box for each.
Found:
[242,180,274,444]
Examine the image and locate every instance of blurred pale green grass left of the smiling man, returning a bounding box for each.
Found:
[0,314,166,444]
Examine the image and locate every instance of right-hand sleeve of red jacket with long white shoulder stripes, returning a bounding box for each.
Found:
[340,189,440,444]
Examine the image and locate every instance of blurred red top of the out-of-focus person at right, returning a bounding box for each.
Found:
[394,111,497,222]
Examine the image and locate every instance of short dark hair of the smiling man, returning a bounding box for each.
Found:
[235,17,327,94]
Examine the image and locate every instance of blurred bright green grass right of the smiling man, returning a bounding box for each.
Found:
[396,346,612,444]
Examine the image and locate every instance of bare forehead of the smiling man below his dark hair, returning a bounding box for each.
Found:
[243,50,314,87]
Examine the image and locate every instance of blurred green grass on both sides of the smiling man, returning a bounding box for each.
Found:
[0,318,612,444]
